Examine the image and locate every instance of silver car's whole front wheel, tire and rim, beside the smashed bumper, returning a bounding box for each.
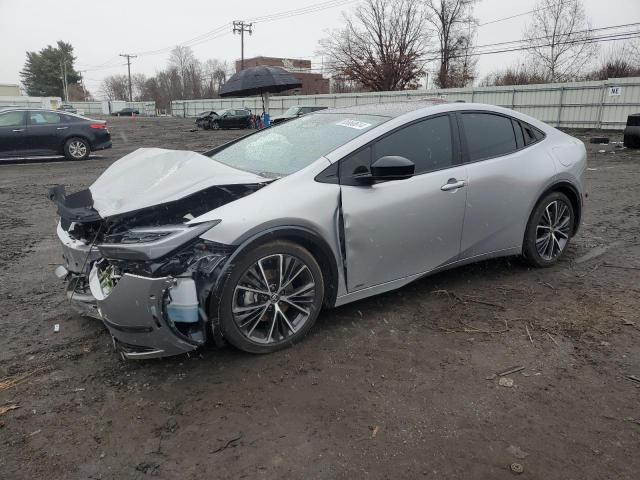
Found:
[219,241,324,353]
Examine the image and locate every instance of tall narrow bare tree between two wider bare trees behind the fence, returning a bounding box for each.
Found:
[425,0,478,88]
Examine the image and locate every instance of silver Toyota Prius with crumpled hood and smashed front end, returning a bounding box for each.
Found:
[49,101,586,358]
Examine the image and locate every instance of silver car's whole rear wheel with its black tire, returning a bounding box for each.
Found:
[523,192,575,268]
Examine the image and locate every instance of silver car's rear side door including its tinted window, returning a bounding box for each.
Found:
[457,111,555,259]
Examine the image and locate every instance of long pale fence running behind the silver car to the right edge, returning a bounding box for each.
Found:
[171,77,640,129]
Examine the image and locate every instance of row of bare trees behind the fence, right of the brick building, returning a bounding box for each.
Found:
[320,0,640,92]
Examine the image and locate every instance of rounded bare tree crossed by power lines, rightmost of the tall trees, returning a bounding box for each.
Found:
[524,0,598,82]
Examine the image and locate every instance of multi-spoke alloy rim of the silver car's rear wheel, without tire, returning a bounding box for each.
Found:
[536,200,571,261]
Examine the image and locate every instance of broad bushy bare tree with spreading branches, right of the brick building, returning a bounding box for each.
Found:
[320,0,425,91]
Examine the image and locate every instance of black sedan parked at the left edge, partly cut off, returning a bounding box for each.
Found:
[0,108,111,160]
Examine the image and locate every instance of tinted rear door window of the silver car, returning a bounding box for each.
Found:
[462,113,517,161]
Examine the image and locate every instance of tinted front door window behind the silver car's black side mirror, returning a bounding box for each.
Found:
[374,115,453,174]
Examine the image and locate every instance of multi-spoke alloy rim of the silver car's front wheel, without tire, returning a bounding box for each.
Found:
[232,254,316,344]
